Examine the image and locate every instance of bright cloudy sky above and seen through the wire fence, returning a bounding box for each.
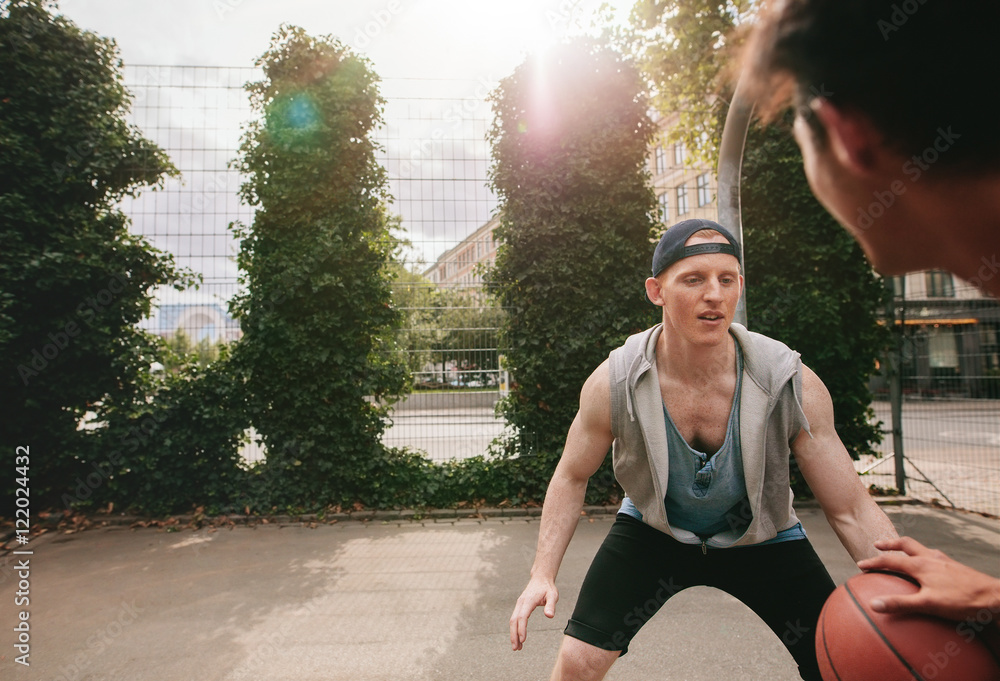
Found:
[47,0,634,328]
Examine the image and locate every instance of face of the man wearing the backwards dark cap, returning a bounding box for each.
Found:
[646,235,743,345]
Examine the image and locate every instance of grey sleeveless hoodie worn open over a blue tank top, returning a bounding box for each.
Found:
[608,323,809,548]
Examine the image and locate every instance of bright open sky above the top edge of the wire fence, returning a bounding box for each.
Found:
[59,0,633,80]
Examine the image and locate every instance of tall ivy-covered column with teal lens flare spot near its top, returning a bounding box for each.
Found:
[232,26,407,507]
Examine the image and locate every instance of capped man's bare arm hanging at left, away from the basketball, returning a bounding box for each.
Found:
[510,361,614,650]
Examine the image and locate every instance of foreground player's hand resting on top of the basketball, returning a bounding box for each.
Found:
[858,537,1000,620]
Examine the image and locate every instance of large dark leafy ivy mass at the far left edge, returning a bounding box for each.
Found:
[0,0,193,507]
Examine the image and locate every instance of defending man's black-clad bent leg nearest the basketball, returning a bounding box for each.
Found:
[718,539,836,681]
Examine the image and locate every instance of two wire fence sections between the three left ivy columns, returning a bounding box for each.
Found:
[123,65,506,460]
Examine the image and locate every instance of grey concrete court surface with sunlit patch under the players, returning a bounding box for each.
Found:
[0,505,1000,681]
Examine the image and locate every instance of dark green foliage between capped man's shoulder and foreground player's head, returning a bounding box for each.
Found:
[741,115,888,456]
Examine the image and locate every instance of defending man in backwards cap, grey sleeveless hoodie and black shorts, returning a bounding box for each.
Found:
[510,220,897,680]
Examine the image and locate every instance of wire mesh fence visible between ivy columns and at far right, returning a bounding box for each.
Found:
[124,65,1000,515]
